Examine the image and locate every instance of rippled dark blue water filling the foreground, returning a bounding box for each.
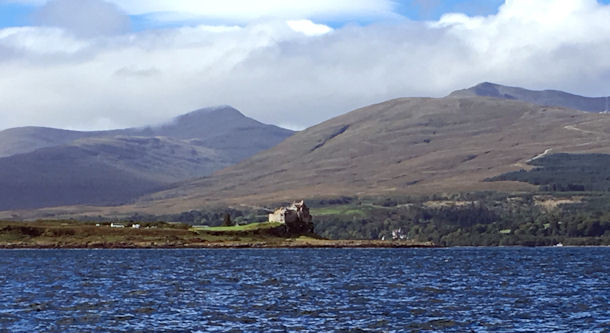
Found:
[0,247,610,332]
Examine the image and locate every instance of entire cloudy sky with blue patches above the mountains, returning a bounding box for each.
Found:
[0,0,610,130]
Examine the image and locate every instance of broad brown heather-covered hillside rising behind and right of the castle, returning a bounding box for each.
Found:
[129,95,610,212]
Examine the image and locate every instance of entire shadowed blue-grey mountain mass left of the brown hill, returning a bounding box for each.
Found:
[0,107,292,210]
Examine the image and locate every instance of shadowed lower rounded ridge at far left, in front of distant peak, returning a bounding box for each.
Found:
[0,137,230,209]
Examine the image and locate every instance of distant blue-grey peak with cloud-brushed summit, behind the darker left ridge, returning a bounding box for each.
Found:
[0,106,293,162]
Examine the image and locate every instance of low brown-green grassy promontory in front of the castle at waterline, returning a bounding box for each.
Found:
[0,220,434,248]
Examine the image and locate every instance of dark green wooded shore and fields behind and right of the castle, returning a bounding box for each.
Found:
[127,191,610,246]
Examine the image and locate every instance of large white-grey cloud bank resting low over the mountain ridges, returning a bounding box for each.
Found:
[0,0,610,128]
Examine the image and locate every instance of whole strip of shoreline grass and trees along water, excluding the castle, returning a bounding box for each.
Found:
[0,191,610,247]
